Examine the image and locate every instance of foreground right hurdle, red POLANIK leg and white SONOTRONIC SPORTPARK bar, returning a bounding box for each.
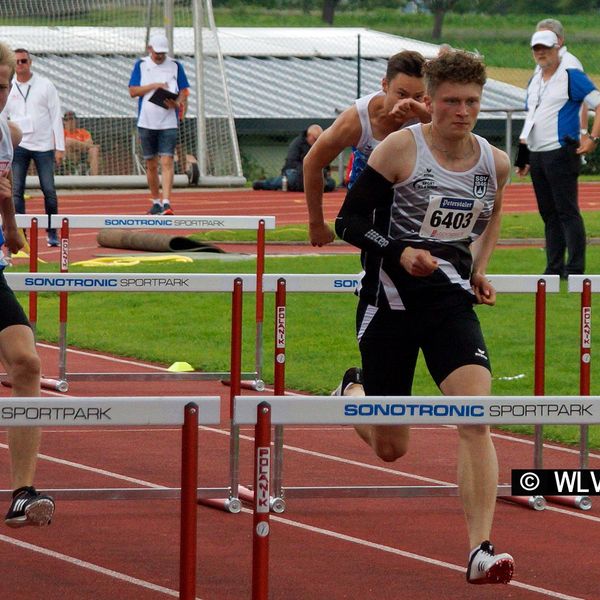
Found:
[234,396,600,600]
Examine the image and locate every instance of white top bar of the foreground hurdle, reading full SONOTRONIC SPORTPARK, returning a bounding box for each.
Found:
[233,396,600,425]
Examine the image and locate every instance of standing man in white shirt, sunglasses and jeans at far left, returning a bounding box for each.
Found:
[5,48,65,246]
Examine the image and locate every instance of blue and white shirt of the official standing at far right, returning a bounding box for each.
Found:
[520,61,600,152]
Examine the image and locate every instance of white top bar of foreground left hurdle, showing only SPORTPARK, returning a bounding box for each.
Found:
[0,396,221,427]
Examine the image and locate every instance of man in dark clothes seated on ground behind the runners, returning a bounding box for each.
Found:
[252,124,335,192]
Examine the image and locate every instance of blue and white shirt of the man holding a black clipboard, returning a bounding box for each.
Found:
[129,56,190,129]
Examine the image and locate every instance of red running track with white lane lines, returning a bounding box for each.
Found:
[0,186,600,600]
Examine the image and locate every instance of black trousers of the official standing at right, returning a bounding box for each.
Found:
[529,145,585,277]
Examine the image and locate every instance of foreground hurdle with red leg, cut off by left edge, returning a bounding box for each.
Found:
[0,396,221,600]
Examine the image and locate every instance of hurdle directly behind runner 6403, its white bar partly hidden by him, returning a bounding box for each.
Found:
[219,274,560,513]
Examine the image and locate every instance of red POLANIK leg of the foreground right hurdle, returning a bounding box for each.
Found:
[252,402,271,600]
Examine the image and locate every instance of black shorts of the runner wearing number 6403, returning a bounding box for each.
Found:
[356,301,491,396]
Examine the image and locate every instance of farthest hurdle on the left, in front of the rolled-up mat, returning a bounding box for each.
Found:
[22,215,275,391]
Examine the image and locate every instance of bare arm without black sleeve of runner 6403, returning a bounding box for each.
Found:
[471,147,510,305]
